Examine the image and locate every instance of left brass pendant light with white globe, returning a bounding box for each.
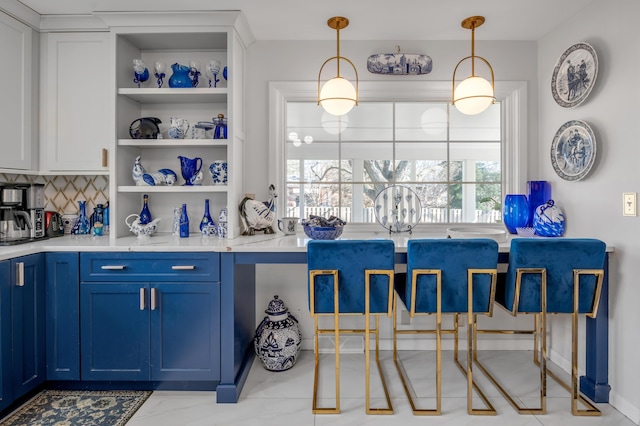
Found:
[318,16,358,116]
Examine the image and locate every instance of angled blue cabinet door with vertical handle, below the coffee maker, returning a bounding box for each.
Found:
[11,254,46,398]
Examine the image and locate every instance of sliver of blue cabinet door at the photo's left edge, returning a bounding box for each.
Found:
[0,260,13,410]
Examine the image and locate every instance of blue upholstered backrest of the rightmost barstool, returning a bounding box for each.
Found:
[496,238,606,313]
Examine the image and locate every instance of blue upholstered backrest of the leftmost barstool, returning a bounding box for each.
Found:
[307,240,395,314]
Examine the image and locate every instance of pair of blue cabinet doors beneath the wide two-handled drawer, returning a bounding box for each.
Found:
[80,282,220,381]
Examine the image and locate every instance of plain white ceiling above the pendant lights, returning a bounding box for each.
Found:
[18,0,594,41]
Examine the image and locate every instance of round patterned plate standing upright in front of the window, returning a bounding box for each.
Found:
[374,185,422,233]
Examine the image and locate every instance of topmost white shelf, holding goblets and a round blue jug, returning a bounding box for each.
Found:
[118,87,228,104]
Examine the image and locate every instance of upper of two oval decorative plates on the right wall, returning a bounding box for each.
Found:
[551,43,598,108]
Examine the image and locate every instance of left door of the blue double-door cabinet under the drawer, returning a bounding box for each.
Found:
[80,282,149,380]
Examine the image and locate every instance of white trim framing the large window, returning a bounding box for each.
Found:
[269,81,528,230]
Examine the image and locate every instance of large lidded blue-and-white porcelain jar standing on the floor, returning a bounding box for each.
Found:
[253,295,302,371]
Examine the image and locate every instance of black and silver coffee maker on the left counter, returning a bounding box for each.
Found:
[0,183,45,245]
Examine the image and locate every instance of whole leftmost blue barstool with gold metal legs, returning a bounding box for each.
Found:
[307,240,395,414]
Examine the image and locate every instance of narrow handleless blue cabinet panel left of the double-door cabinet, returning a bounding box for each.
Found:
[45,253,80,380]
